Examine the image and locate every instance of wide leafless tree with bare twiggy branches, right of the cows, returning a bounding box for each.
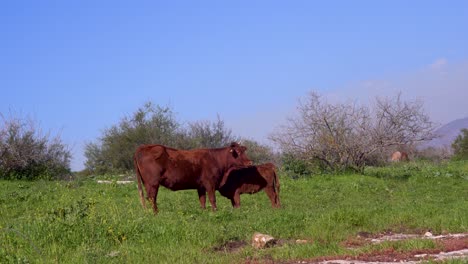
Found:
[270,92,433,171]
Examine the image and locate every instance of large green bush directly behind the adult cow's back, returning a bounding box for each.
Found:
[85,102,243,174]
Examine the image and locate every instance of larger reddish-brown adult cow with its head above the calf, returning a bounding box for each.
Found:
[133,143,252,213]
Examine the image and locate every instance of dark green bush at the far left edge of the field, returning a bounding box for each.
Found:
[0,115,71,180]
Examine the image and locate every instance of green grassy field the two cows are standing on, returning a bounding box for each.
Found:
[0,162,468,263]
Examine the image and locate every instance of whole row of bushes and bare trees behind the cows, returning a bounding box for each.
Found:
[4,92,468,177]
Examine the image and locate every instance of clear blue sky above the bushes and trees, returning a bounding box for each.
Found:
[0,0,468,170]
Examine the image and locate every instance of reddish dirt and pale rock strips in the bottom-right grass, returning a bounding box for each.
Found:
[212,232,468,264]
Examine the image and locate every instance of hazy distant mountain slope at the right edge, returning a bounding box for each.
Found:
[420,117,468,149]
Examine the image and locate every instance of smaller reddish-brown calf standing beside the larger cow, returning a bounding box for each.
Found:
[218,163,281,208]
